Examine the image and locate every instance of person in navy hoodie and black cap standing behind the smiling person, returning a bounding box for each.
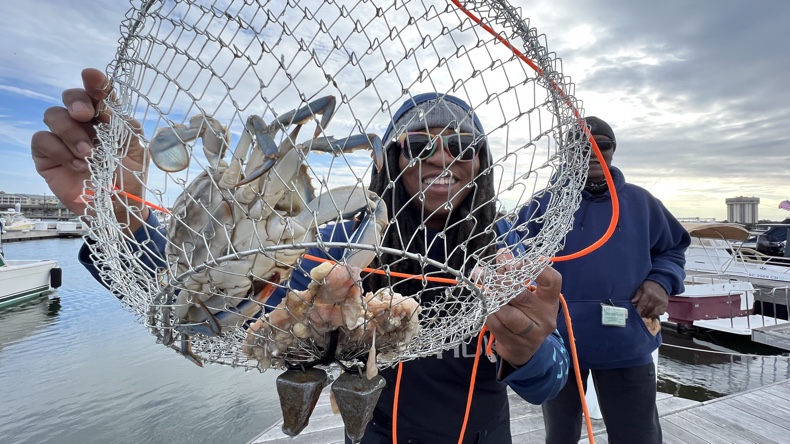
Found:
[517,116,690,444]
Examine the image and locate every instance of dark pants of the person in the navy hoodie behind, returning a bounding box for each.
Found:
[542,362,662,444]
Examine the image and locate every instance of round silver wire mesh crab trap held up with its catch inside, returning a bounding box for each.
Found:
[85,0,589,370]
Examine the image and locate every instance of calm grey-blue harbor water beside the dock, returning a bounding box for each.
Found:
[0,239,790,444]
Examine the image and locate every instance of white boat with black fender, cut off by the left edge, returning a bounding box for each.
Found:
[0,231,62,309]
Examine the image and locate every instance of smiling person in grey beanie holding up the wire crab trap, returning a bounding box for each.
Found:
[31,69,569,443]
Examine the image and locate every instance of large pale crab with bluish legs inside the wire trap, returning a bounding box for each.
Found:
[148,96,387,365]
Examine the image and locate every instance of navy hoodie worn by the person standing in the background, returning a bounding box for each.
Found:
[518,168,690,369]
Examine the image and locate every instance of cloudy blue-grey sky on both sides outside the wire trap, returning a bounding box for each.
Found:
[0,0,790,220]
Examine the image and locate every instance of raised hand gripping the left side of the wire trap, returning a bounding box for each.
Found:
[30,68,148,232]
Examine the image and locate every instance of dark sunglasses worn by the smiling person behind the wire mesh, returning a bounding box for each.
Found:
[398,132,486,162]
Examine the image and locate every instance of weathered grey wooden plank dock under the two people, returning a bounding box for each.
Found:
[250,380,790,444]
